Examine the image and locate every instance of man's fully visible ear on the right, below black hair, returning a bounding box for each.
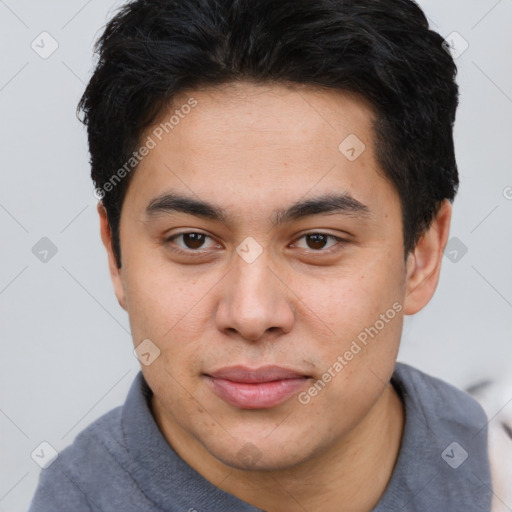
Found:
[404,200,452,315]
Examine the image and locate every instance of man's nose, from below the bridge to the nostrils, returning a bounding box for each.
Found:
[216,245,295,342]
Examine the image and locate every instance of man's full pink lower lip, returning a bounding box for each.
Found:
[205,377,309,409]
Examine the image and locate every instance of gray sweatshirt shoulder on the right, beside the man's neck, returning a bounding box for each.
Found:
[376,363,492,512]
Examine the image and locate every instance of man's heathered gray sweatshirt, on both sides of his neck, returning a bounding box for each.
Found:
[29,363,492,512]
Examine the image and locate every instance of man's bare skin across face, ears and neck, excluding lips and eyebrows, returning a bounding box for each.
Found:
[98,82,451,512]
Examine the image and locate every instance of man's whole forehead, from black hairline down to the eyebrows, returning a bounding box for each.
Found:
[123,82,396,226]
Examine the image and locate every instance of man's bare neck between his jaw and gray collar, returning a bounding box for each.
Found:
[153,384,404,512]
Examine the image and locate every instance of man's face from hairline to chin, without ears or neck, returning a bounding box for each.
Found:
[112,83,406,469]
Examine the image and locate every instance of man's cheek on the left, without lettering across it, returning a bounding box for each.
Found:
[125,261,212,402]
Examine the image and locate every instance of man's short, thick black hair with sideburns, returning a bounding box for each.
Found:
[78,0,458,267]
